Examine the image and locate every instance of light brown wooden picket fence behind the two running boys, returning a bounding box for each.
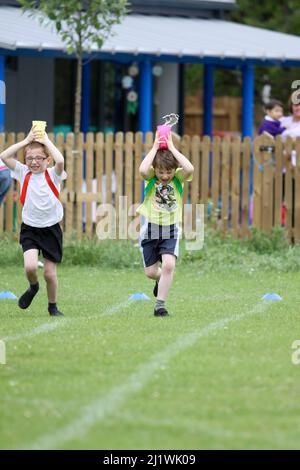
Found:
[0,132,300,243]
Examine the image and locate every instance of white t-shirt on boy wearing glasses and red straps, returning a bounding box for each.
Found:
[12,161,67,227]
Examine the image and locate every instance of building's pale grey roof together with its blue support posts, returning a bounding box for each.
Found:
[0,1,300,136]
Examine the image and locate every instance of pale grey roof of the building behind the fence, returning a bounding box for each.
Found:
[0,7,300,65]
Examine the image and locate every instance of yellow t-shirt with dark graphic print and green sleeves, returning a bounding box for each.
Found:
[137,167,192,225]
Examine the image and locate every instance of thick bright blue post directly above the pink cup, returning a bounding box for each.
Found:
[139,60,152,133]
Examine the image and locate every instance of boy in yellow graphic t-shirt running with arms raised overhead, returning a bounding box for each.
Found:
[137,133,194,317]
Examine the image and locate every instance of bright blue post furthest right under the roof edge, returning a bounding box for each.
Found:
[242,64,254,137]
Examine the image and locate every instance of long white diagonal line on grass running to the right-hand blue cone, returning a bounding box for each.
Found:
[22,302,271,449]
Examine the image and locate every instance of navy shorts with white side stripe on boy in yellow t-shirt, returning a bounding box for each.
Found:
[140,223,179,268]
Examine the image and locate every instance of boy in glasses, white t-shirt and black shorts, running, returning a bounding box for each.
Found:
[0,127,66,316]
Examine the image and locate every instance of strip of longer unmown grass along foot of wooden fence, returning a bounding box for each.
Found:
[0,227,300,272]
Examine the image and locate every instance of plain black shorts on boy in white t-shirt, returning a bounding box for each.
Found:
[20,223,62,263]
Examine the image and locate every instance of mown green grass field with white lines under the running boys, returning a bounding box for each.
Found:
[0,263,300,449]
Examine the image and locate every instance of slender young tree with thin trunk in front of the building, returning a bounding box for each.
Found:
[19,0,128,134]
